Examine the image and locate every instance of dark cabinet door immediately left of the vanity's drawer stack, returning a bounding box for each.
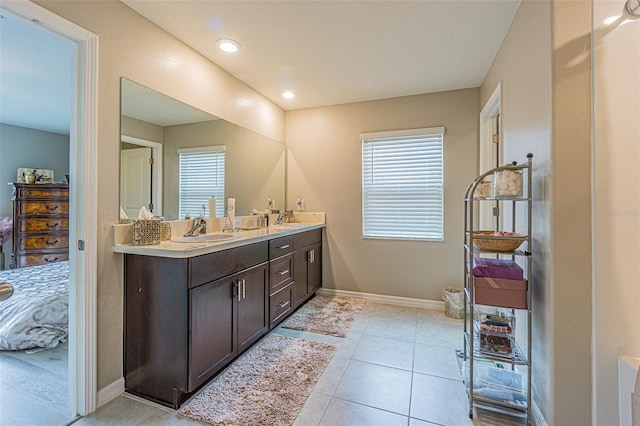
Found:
[237,263,269,353]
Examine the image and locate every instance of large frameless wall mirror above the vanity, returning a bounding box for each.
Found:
[120,78,285,220]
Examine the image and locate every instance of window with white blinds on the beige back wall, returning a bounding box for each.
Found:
[361,127,444,241]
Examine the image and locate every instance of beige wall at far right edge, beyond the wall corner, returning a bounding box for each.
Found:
[593,1,640,424]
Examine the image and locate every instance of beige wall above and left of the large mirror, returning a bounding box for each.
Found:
[36,0,284,389]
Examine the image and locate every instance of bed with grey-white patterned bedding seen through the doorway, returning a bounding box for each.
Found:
[0,261,69,351]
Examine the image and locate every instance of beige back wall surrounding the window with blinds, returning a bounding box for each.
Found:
[286,89,479,300]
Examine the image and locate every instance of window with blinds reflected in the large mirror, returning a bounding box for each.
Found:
[178,146,225,219]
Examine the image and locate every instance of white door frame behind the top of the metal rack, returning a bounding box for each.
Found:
[478,82,503,229]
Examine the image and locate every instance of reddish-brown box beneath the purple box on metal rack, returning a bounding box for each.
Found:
[473,277,527,309]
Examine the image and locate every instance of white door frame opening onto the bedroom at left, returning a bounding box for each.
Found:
[0,0,98,416]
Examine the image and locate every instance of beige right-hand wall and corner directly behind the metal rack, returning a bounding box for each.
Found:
[481,0,591,425]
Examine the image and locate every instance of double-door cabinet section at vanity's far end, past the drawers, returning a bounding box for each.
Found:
[293,229,322,308]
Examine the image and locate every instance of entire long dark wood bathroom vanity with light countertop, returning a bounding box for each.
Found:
[114,224,324,408]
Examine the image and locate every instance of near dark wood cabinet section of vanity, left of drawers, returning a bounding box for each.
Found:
[124,242,269,408]
